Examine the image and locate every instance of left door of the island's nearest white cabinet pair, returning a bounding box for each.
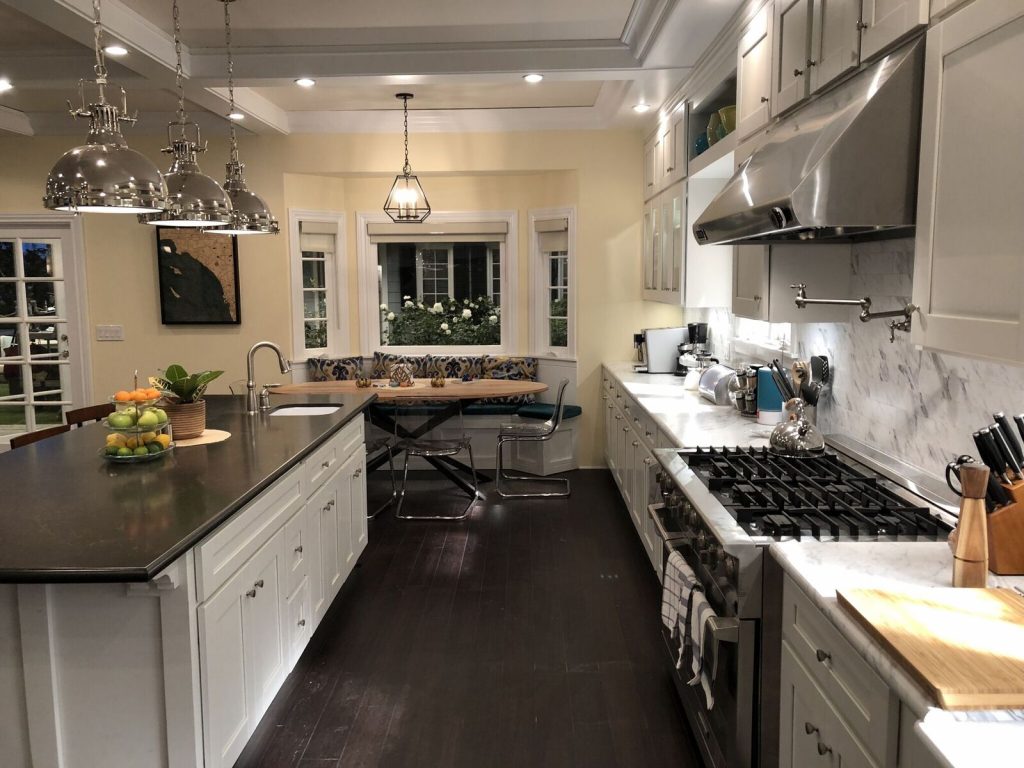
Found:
[198,567,251,768]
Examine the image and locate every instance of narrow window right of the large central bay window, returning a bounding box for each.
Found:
[530,209,575,356]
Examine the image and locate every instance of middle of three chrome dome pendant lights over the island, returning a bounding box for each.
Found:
[138,0,231,227]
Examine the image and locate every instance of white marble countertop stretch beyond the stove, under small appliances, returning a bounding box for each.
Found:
[604,362,772,449]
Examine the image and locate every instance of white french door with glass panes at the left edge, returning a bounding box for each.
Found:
[0,217,89,444]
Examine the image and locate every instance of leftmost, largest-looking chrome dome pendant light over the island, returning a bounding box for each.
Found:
[43,0,167,213]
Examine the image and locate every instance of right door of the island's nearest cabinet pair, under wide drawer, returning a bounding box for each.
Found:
[242,529,288,725]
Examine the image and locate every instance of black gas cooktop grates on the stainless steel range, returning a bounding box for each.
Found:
[680,447,950,542]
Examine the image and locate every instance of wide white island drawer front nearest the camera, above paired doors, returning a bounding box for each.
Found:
[196,467,305,603]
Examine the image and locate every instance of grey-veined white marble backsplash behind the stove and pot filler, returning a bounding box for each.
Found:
[793,239,1024,476]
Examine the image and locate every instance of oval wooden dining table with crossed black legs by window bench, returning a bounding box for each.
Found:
[270,379,548,495]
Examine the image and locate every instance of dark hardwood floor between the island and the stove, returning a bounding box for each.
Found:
[238,470,700,768]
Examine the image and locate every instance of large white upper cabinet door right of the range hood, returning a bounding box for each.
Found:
[911,0,1024,362]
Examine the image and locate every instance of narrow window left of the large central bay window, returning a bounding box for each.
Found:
[289,211,348,356]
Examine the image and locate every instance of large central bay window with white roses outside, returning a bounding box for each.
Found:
[358,213,514,354]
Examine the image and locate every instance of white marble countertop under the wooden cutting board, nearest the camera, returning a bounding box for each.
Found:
[770,541,1024,768]
